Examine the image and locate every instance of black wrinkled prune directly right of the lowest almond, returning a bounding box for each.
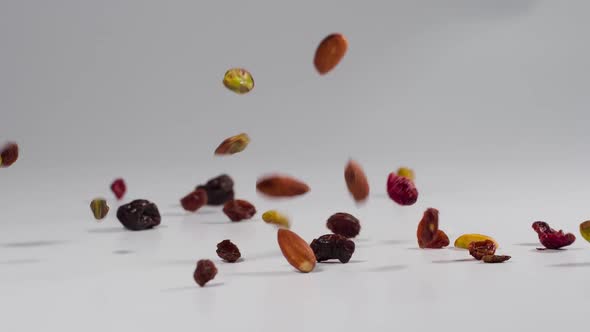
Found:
[310,234,354,263]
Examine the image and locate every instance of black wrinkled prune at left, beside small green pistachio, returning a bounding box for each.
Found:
[117,199,161,231]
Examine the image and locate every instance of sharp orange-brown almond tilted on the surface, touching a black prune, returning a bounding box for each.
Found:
[277,228,316,273]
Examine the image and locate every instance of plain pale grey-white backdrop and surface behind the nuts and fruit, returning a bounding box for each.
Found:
[0,0,590,331]
